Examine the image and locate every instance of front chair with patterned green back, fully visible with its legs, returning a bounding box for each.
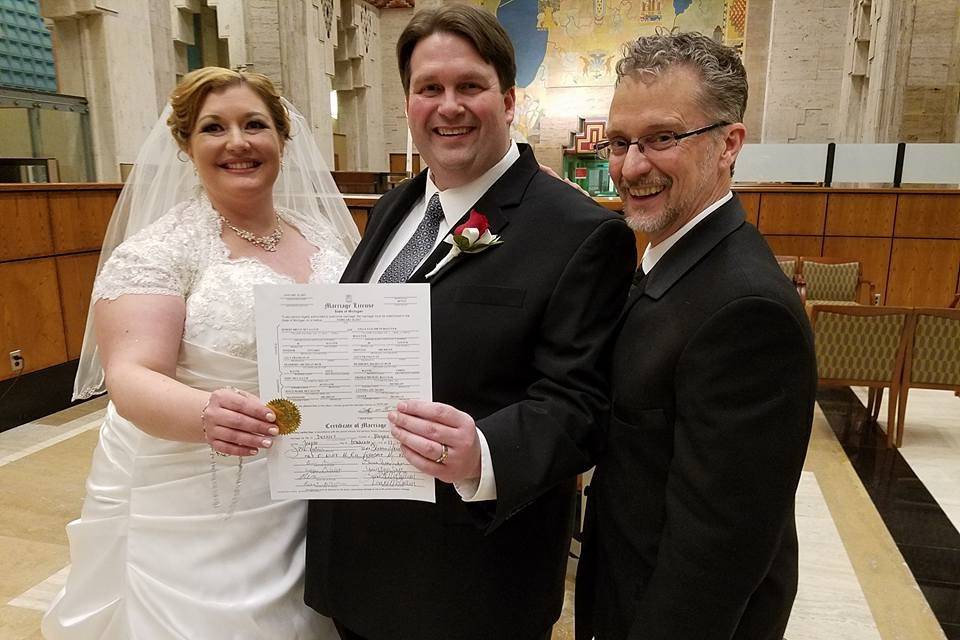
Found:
[811,304,913,447]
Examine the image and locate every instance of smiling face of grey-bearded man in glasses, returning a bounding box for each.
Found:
[607,67,745,245]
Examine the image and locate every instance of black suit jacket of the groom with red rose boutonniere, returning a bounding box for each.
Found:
[305,145,636,640]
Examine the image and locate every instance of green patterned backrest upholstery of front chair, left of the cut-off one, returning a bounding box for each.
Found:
[804,314,906,382]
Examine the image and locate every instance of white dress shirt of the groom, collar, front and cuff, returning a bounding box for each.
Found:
[369,140,520,502]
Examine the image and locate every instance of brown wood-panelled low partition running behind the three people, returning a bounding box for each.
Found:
[0,184,960,380]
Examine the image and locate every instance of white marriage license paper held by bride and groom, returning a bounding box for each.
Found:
[255,284,436,502]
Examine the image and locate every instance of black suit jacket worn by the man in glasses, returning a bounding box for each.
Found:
[576,197,816,640]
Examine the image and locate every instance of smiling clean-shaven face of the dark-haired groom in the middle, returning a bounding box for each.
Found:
[407,31,515,189]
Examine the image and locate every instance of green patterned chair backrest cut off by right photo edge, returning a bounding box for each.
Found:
[910,315,960,386]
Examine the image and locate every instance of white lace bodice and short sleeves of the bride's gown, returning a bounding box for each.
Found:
[92,196,349,360]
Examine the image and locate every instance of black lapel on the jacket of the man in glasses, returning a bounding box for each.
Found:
[627,194,745,308]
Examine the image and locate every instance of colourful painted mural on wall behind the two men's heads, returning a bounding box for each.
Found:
[475,0,747,143]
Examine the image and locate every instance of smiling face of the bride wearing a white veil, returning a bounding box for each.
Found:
[187,84,283,206]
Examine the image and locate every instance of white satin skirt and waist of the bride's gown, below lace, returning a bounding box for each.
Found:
[42,343,339,640]
